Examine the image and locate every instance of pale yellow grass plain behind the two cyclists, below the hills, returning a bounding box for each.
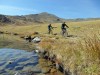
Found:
[0,20,100,35]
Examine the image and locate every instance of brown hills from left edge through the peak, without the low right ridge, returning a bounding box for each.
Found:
[0,12,64,25]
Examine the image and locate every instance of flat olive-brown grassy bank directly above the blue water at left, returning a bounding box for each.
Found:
[0,34,35,51]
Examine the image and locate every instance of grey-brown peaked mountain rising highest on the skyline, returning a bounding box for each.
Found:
[25,12,63,23]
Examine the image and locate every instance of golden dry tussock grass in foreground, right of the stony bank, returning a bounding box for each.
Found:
[40,36,100,75]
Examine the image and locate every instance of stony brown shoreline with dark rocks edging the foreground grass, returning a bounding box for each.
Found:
[36,44,64,75]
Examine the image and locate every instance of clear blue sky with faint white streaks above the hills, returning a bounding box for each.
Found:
[0,0,100,19]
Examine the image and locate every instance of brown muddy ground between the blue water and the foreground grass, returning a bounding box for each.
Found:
[38,51,64,75]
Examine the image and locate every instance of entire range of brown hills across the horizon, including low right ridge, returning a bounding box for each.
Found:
[0,12,100,25]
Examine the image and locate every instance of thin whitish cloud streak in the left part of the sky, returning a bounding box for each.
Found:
[0,5,38,12]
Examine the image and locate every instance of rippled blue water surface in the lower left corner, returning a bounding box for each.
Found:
[0,48,38,75]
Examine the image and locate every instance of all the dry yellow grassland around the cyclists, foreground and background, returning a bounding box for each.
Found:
[0,20,100,75]
